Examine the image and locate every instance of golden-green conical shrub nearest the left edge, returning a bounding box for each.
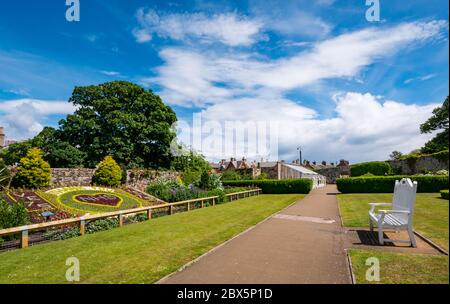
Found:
[14,148,51,189]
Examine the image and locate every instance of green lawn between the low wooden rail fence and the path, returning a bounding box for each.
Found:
[0,194,303,283]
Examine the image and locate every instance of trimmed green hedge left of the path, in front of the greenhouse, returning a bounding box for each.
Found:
[223,178,313,194]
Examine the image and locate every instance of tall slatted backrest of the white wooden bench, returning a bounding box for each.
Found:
[392,178,417,215]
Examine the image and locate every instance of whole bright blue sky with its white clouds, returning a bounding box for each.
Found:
[0,0,448,161]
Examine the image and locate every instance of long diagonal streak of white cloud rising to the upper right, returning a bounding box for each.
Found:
[150,21,448,106]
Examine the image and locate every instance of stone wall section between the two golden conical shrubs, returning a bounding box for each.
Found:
[51,168,95,187]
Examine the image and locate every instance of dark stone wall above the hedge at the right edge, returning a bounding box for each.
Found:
[388,155,449,174]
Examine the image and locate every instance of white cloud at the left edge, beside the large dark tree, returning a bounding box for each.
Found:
[0,99,75,140]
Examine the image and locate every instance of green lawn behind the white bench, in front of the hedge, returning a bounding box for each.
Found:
[338,193,449,250]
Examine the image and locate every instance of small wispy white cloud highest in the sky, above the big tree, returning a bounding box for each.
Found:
[133,8,262,46]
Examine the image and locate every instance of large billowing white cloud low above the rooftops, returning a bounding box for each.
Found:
[195,92,438,162]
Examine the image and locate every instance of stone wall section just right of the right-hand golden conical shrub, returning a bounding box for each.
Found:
[127,169,180,191]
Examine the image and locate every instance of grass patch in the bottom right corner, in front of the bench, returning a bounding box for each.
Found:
[349,249,449,284]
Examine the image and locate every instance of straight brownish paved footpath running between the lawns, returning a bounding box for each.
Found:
[159,185,351,284]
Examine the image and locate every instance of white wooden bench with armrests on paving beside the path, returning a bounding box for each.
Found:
[369,178,417,247]
